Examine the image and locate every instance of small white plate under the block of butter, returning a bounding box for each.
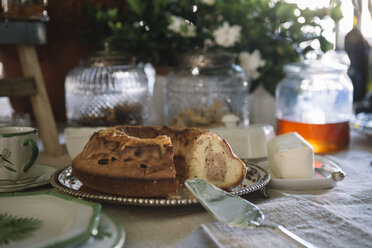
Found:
[258,155,345,190]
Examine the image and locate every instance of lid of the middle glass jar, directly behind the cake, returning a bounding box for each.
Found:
[180,52,235,68]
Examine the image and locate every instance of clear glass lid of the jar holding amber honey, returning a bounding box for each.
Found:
[284,59,347,74]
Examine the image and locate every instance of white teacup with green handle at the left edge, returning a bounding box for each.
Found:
[0,127,39,181]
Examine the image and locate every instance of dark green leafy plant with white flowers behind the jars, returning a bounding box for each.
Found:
[81,0,342,124]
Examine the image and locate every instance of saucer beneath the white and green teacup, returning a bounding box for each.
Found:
[0,164,57,193]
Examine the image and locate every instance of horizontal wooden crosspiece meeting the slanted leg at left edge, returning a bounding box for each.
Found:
[0,78,37,96]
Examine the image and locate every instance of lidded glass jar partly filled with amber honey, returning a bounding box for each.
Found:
[275,60,353,153]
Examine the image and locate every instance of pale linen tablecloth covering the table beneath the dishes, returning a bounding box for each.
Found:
[33,131,372,248]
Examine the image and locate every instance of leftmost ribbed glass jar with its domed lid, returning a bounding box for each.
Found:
[65,52,149,126]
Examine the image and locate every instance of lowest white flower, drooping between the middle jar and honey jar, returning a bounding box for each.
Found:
[239,50,266,80]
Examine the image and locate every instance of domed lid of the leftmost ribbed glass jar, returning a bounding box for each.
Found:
[80,51,135,67]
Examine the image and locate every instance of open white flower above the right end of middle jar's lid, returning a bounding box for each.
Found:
[213,22,242,47]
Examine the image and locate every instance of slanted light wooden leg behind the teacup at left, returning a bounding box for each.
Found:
[17,45,62,156]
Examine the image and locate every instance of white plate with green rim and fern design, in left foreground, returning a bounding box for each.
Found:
[0,191,101,248]
